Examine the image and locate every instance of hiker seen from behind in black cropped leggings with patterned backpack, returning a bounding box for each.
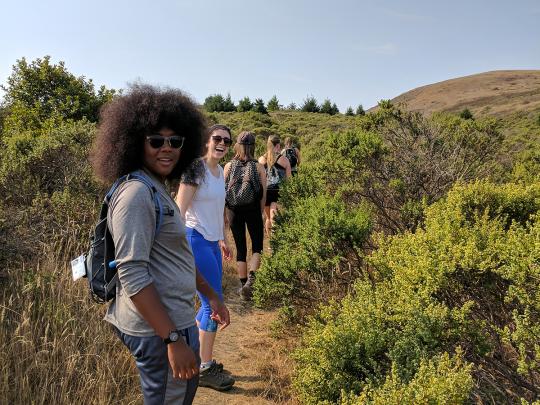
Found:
[225,131,266,300]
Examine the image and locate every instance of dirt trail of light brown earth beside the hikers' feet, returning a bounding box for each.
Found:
[194,266,283,405]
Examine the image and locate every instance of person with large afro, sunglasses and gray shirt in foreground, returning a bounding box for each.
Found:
[92,84,229,405]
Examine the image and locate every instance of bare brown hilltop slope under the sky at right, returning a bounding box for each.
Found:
[380,70,540,116]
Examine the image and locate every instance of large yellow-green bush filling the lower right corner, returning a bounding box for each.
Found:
[294,183,540,403]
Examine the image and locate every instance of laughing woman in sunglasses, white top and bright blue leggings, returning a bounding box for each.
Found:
[176,124,234,391]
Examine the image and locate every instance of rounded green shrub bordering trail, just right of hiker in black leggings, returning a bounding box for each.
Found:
[254,194,371,318]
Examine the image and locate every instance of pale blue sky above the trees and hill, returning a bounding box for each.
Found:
[0,0,540,112]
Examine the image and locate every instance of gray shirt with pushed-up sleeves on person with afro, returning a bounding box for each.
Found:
[105,167,196,336]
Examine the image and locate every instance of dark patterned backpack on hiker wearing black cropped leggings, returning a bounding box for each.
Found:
[225,159,262,209]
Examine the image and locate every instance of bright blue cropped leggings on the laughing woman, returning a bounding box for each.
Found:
[186,227,223,332]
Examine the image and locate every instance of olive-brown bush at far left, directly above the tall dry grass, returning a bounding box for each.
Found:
[0,120,103,256]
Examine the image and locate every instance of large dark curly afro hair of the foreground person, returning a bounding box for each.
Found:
[90,84,207,183]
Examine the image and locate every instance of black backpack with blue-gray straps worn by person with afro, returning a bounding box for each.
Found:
[85,173,163,303]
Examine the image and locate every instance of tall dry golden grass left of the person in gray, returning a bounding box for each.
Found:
[0,243,141,404]
